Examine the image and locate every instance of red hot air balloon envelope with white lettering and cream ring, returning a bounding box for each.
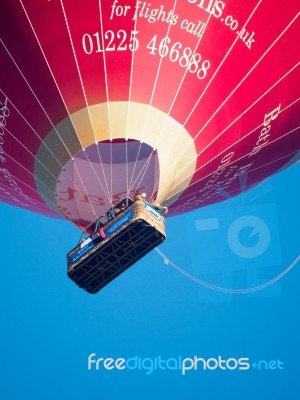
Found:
[0,0,300,227]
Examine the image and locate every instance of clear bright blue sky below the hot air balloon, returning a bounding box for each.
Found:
[0,165,300,400]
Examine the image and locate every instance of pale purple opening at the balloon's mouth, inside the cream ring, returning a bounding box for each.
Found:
[55,138,159,227]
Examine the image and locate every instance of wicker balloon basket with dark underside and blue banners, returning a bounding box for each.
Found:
[67,200,166,294]
